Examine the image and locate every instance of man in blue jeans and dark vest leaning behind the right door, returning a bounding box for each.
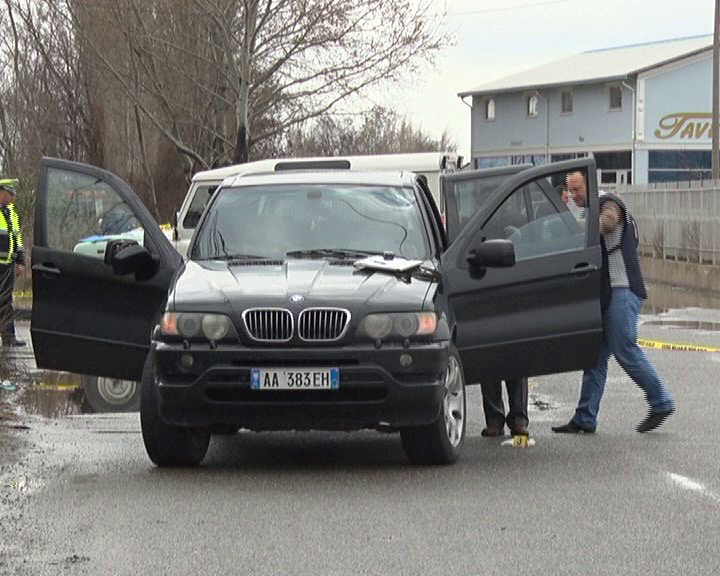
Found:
[552,172,675,433]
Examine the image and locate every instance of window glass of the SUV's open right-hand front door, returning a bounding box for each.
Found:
[481,171,586,261]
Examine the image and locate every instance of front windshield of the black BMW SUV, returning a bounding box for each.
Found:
[191,184,428,260]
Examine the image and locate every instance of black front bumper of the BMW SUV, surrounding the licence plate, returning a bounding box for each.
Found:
[153,342,449,430]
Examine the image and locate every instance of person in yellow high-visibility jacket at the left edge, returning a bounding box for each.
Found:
[0,179,25,346]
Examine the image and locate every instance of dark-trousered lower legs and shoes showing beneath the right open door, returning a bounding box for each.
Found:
[480,378,529,437]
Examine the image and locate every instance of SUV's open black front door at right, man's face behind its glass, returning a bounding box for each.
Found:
[436,159,602,383]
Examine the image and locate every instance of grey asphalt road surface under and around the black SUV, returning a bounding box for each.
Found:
[0,311,720,576]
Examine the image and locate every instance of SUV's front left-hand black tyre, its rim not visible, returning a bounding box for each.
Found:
[140,352,210,466]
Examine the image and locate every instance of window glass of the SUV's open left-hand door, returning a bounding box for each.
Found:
[46,168,145,258]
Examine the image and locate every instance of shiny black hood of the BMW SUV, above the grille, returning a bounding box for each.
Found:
[171,259,434,312]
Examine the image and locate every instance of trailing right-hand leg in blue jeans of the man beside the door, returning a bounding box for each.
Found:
[609,290,675,426]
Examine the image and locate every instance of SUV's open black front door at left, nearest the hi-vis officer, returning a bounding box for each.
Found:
[31,158,182,380]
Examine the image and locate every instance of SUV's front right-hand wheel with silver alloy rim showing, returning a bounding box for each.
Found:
[400,345,466,464]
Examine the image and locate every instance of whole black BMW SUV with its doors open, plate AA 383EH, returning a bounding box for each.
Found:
[32,159,601,466]
